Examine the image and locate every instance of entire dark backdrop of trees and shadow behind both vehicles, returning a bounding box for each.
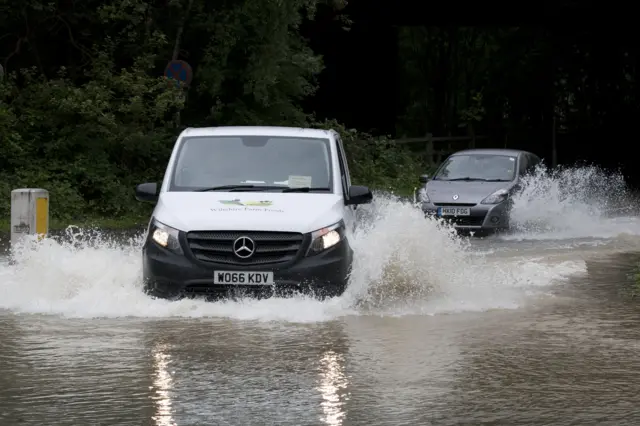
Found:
[0,0,640,220]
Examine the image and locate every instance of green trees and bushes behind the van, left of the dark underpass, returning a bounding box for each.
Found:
[0,0,436,223]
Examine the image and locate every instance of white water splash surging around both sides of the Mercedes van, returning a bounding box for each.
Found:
[0,194,584,322]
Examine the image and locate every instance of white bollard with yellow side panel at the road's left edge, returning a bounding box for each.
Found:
[11,188,49,246]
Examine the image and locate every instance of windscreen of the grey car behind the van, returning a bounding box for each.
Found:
[433,154,516,181]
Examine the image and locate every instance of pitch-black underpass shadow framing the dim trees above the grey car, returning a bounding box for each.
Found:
[304,0,640,187]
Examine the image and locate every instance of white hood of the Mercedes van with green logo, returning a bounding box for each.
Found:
[154,192,344,233]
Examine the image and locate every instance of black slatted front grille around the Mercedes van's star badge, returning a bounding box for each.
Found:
[187,231,304,265]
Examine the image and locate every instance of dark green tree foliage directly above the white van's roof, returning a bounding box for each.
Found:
[187,0,323,125]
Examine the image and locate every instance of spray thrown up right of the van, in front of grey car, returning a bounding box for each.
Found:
[346,198,583,314]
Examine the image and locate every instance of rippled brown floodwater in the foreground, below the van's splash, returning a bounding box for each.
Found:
[0,251,640,426]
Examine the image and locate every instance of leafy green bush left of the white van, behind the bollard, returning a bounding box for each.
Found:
[0,57,183,223]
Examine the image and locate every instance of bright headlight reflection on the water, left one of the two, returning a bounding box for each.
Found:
[151,343,176,426]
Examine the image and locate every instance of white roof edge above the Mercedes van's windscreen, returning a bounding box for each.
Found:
[176,126,336,138]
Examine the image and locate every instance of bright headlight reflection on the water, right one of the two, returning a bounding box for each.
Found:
[318,350,349,426]
